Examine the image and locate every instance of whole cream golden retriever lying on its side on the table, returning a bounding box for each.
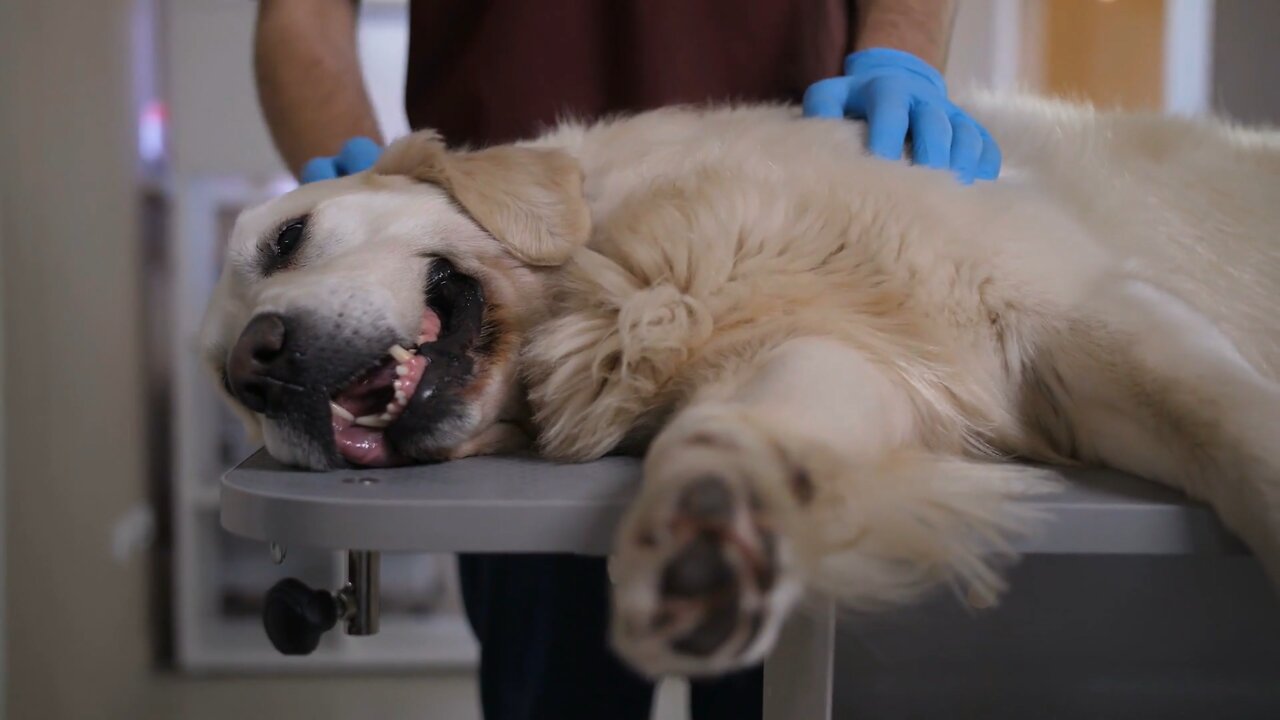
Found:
[204,96,1280,674]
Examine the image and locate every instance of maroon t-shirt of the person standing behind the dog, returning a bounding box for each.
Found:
[404,0,852,146]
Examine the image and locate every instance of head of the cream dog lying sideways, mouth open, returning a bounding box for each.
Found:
[202,132,590,469]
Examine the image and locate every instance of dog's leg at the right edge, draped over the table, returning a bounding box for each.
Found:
[1033,279,1280,583]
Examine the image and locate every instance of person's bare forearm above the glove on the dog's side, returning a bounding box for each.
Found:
[851,0,955,70]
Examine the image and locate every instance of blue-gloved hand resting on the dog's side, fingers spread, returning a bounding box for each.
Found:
[804,47,1000,184]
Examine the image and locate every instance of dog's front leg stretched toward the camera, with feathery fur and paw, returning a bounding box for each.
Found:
[612,340,1054,675]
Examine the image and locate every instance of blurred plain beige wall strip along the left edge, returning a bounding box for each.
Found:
[0,0,148,719]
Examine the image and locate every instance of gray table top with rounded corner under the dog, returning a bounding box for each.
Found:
[221,451,1243,555]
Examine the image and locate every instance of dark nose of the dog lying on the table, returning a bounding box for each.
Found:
[227,313,294,413]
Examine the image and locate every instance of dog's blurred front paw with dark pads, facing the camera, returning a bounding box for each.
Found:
[612,474,800,676]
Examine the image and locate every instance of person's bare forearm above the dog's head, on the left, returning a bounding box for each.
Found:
[253,0,381,174]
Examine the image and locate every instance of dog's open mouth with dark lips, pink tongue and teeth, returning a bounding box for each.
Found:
[329,260,484,468]
